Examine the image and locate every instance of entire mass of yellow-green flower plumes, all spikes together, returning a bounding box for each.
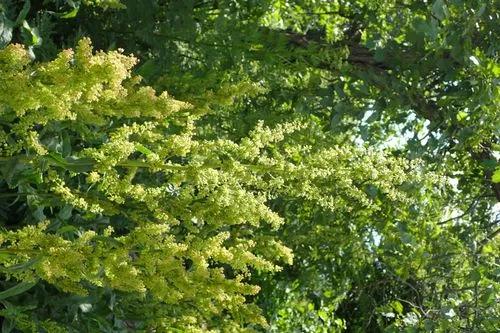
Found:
[0,39,426,332]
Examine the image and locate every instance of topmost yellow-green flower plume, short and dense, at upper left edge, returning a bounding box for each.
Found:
[0,39,189,154]
